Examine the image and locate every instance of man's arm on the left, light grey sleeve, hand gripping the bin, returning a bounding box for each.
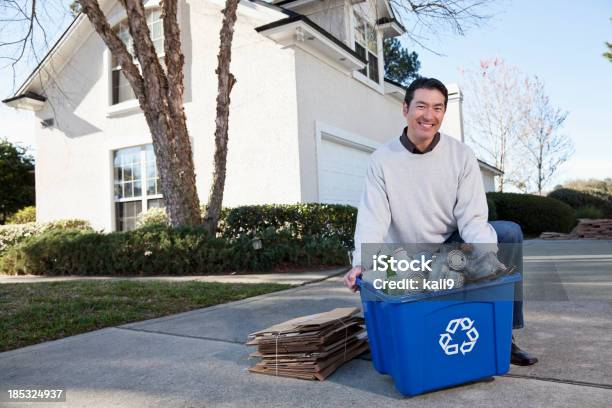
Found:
[344,157,391,291]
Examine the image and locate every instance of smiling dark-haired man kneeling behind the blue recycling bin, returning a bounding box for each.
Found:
[344,78,538,365]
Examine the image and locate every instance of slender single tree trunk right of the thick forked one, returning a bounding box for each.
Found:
[204,0,239,235]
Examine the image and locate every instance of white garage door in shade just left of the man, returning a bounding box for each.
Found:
[318,133,374,207]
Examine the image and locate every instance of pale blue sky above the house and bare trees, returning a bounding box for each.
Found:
[0,0,612,187]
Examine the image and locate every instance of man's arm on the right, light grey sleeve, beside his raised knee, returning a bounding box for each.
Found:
[453,149,497,247]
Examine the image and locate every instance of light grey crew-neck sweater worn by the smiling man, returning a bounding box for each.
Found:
[353,134,497,266]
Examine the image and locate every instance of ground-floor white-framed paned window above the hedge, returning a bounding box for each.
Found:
[113,144,164,231]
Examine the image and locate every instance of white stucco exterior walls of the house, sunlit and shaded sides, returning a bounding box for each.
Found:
[25,0,494,231]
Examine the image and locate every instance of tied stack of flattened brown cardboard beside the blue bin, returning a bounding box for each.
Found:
[247,307,368,381]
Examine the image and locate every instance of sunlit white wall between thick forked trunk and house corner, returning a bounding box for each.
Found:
[179,0,300,207]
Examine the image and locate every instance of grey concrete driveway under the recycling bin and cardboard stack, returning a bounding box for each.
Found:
[0,240,612,408]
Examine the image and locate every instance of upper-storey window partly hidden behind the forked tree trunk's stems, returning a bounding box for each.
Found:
[112,9,164,105]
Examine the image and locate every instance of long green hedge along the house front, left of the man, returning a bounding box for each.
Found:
[0,204,357,275]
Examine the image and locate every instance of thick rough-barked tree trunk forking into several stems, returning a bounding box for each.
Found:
[79,0,201,226]
